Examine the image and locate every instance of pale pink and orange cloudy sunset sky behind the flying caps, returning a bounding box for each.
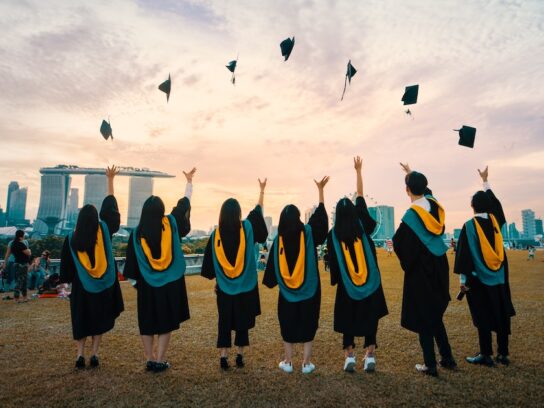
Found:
[0,0,544,231]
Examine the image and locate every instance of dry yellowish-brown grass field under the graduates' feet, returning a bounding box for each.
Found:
[0,251,544,407]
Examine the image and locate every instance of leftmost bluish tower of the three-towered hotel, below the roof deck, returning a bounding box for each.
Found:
[34,174,72,234]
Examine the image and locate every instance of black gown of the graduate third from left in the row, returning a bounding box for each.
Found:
[200,205,268,332]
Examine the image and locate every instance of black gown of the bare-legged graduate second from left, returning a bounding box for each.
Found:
[123,197,191,336]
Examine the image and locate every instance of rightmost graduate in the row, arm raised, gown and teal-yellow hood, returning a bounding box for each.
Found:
[453,167,516,367]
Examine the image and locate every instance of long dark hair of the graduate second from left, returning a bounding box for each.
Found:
[136,196,164,259]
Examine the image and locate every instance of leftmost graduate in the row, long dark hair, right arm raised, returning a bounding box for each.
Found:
[60,166,124,368]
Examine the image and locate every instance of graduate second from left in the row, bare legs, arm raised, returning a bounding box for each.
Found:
[123,169,196,372]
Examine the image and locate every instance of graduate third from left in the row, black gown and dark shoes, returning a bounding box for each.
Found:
[201,179,268,370]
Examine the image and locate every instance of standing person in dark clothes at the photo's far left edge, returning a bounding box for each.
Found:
[3,230,31,303]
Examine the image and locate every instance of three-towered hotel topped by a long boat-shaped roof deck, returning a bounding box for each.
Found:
[34,165,175,234]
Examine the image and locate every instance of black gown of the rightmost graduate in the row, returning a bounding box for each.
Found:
[453,190,516,334]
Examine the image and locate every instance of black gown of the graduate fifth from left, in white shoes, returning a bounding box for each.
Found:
[327,197,389,336]
